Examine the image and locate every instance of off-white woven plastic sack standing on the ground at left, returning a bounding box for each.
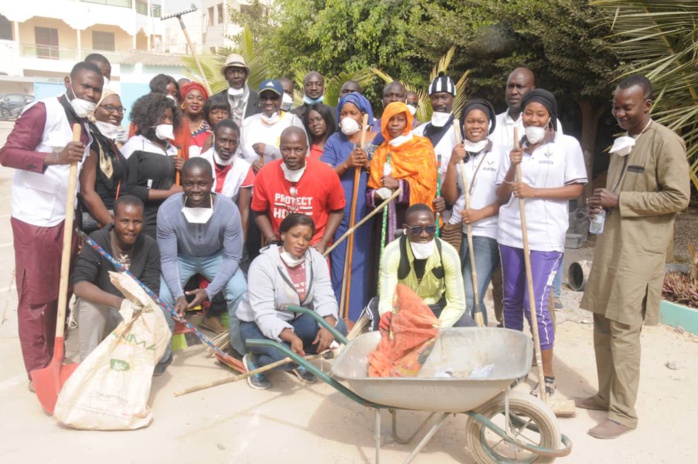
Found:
[54,272,171,430]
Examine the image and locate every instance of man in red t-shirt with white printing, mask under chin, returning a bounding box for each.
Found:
[252,127,345,253]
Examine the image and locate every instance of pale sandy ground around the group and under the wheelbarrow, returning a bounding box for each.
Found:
[0,123,698,464]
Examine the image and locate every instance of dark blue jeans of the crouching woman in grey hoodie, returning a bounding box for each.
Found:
[240,314,347,371]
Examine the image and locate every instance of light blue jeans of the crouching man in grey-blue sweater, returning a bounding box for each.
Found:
[160,253,247,359]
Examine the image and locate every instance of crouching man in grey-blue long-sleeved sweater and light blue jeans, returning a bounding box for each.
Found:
[157,157,247,366]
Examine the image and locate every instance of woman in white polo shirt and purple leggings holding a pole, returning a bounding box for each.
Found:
[497,89,587,395]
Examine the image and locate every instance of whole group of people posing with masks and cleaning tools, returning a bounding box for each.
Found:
[0,49,689,438]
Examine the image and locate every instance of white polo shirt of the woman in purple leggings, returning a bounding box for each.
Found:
[497,134,587,253]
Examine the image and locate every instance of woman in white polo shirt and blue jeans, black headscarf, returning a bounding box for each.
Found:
[441,98,502,324]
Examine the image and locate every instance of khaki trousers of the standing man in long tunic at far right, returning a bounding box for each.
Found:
[594,314,642,429]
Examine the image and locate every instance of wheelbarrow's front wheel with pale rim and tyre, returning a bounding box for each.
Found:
[465,391,560,464]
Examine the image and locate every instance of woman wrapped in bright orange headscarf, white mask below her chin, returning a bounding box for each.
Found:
[366,102,437,243]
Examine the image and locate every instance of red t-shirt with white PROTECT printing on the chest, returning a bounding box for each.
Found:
[251,158,346,244]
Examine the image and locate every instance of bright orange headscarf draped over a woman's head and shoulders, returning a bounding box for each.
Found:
[368,102,437,208]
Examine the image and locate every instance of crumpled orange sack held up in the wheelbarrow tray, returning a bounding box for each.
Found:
[368,284,441,377]
